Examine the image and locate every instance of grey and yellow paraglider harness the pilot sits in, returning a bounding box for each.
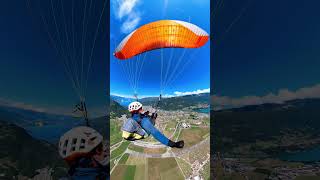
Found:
[121,95,161,141]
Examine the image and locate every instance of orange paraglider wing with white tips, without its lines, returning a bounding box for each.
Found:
[114,20,209,60]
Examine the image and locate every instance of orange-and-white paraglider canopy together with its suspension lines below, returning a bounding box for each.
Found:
[113,20,209,101]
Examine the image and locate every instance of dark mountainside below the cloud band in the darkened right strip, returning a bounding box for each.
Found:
[211,99,320,152]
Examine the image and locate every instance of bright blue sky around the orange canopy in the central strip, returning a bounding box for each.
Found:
[110,0,210,97]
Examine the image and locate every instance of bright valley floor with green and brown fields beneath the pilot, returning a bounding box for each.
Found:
[110,111,210,180]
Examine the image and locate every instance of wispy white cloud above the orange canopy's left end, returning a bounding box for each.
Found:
[112,0,141,33]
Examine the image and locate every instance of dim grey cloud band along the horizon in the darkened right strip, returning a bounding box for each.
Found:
[211,84,320,109]
